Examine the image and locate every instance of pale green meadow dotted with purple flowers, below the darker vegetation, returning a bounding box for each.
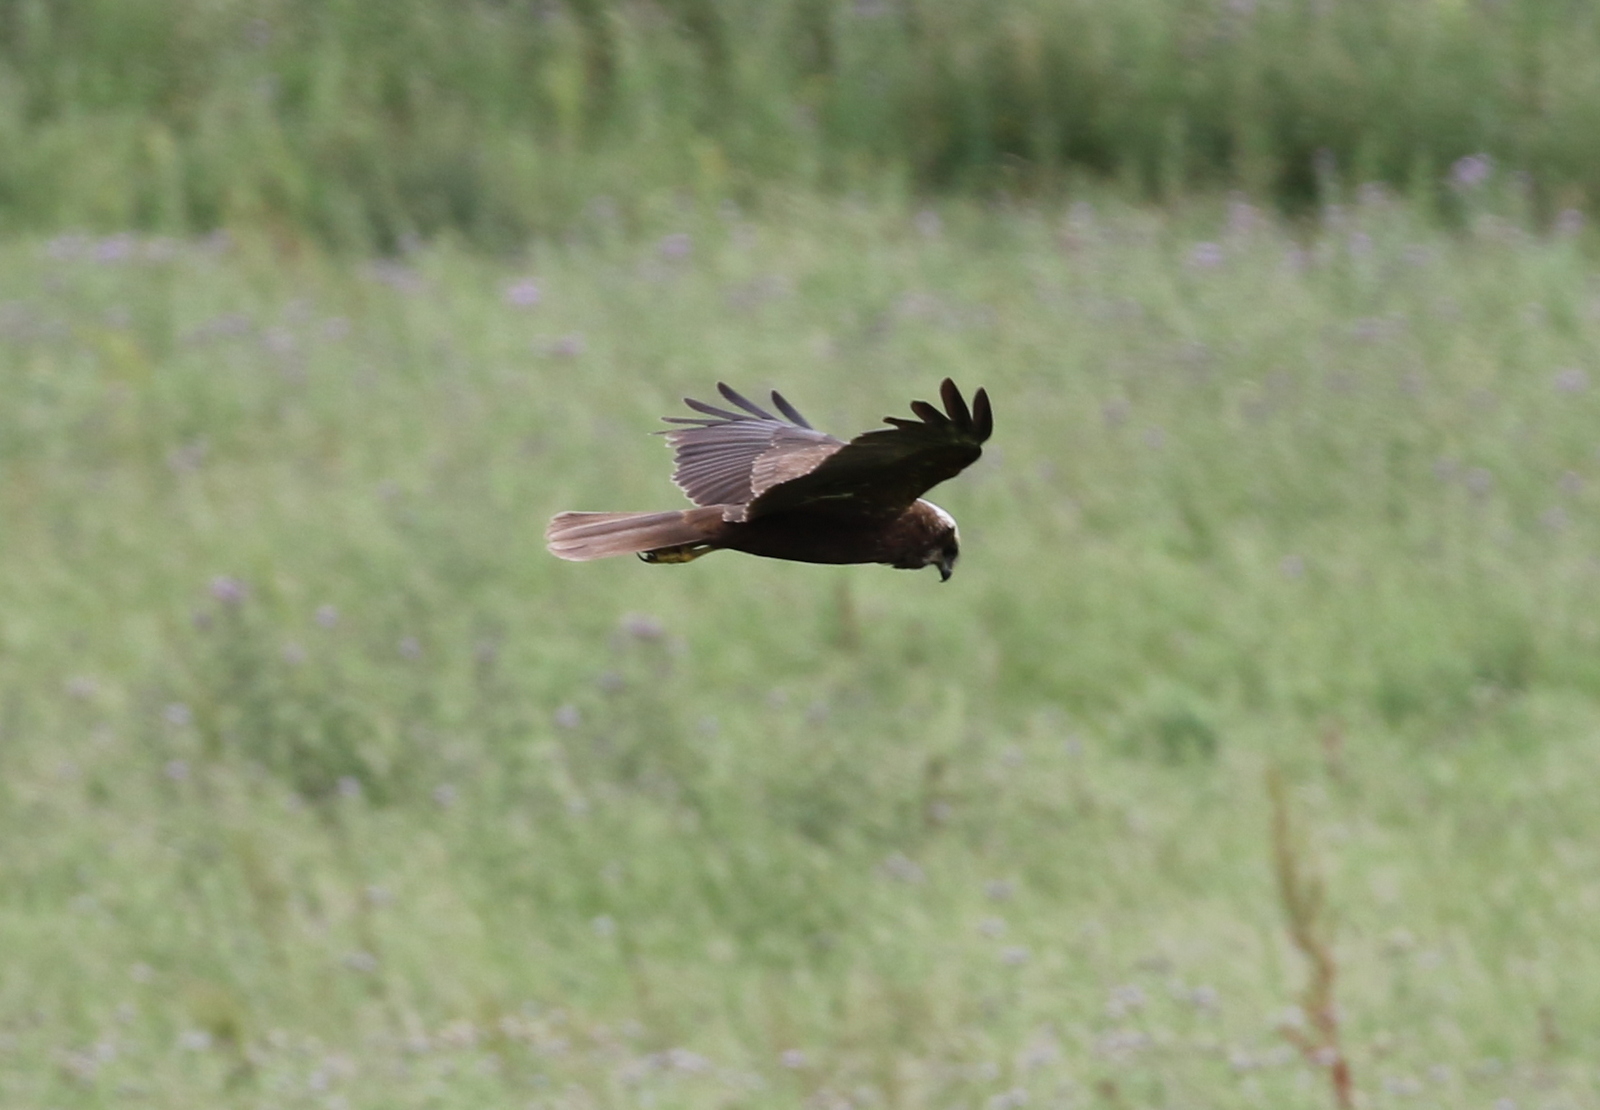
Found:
[0,189,1600,1110]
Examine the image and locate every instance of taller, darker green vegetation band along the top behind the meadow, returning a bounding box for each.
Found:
[0,0,1600,251]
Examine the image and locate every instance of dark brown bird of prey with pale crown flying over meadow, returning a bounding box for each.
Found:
[546,379,994,581]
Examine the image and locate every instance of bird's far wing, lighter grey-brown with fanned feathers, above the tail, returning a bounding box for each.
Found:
[662,382,845,520]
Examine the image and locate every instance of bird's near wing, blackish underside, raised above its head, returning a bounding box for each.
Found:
[746,377,994,518]
